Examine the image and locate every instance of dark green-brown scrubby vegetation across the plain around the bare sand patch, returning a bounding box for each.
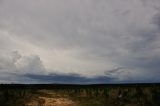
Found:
[0,84,160,106]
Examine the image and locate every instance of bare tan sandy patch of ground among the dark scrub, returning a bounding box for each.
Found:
[27,91,78,106]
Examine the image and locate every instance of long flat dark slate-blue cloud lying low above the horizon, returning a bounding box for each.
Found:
[23,74,115,84]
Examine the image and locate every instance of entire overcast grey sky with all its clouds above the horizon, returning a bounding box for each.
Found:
[0,0,160,84]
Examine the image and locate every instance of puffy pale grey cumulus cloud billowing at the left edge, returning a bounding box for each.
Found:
[0,51,45,82]
